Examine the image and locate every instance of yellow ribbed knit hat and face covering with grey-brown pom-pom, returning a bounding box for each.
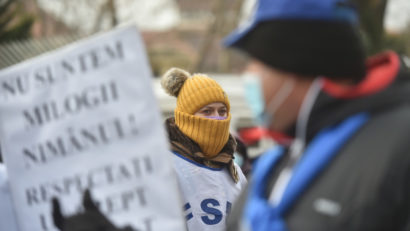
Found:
[161,68,231,157]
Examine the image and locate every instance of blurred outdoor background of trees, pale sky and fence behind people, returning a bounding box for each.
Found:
[0,0,410,153]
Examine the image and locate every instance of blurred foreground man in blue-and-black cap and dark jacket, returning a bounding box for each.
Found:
[226,0,410,231]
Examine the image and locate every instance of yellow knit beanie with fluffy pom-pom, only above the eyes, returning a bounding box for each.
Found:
[161,68,230,115]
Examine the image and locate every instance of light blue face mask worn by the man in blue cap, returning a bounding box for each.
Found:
[242,72,294,128]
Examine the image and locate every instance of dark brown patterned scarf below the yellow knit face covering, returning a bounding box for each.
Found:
[165,117,239,183]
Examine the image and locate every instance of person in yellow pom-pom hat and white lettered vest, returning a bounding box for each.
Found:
[161,68,246,231]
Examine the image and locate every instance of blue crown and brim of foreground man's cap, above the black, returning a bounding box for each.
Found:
[224,0,358,46]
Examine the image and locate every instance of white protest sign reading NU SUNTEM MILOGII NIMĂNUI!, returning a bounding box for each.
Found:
[0,27,185,231]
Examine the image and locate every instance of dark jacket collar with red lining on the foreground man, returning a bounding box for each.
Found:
[306,52,410,142]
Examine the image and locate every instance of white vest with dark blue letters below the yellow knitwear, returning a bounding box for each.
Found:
[174,153,247,231]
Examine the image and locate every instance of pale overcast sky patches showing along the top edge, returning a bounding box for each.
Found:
[36,0,410,32]
